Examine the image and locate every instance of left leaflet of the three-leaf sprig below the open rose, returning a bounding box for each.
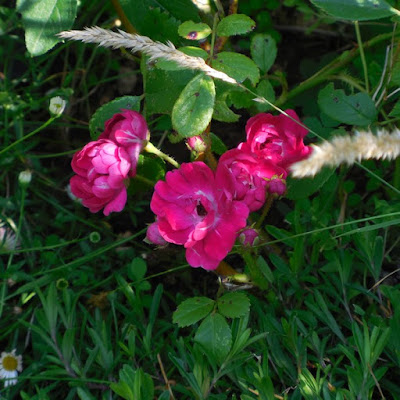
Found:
[172,297,215,328]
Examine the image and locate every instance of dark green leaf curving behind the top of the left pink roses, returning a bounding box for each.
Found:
[89,96,141,140]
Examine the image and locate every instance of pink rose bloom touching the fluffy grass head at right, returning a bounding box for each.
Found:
[238,110,311,169]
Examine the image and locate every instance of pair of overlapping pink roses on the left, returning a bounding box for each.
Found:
[70,110,149,215]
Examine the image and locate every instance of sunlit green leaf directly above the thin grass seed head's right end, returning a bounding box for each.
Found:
[212,51,260,85]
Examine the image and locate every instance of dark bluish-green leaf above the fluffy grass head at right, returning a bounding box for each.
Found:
[318,83,377,126]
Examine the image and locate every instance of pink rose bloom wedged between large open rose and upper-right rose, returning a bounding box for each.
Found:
[216,149,287,211]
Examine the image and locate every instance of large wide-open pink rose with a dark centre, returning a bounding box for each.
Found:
[150,162,249,270]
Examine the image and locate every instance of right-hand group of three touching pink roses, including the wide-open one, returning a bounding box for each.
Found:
[147,110,311,270]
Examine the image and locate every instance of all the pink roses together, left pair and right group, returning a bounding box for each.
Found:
[70,110,311,270]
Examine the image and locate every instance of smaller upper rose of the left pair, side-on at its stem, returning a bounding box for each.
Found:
[99,110,149,176]
